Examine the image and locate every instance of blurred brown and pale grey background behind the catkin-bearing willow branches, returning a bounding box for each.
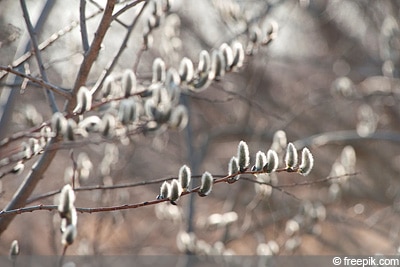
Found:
[0,0,400,255]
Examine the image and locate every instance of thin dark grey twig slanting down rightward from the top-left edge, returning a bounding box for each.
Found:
[20,0,58,113]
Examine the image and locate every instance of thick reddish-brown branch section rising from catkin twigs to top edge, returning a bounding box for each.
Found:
[66,0,116,113]
